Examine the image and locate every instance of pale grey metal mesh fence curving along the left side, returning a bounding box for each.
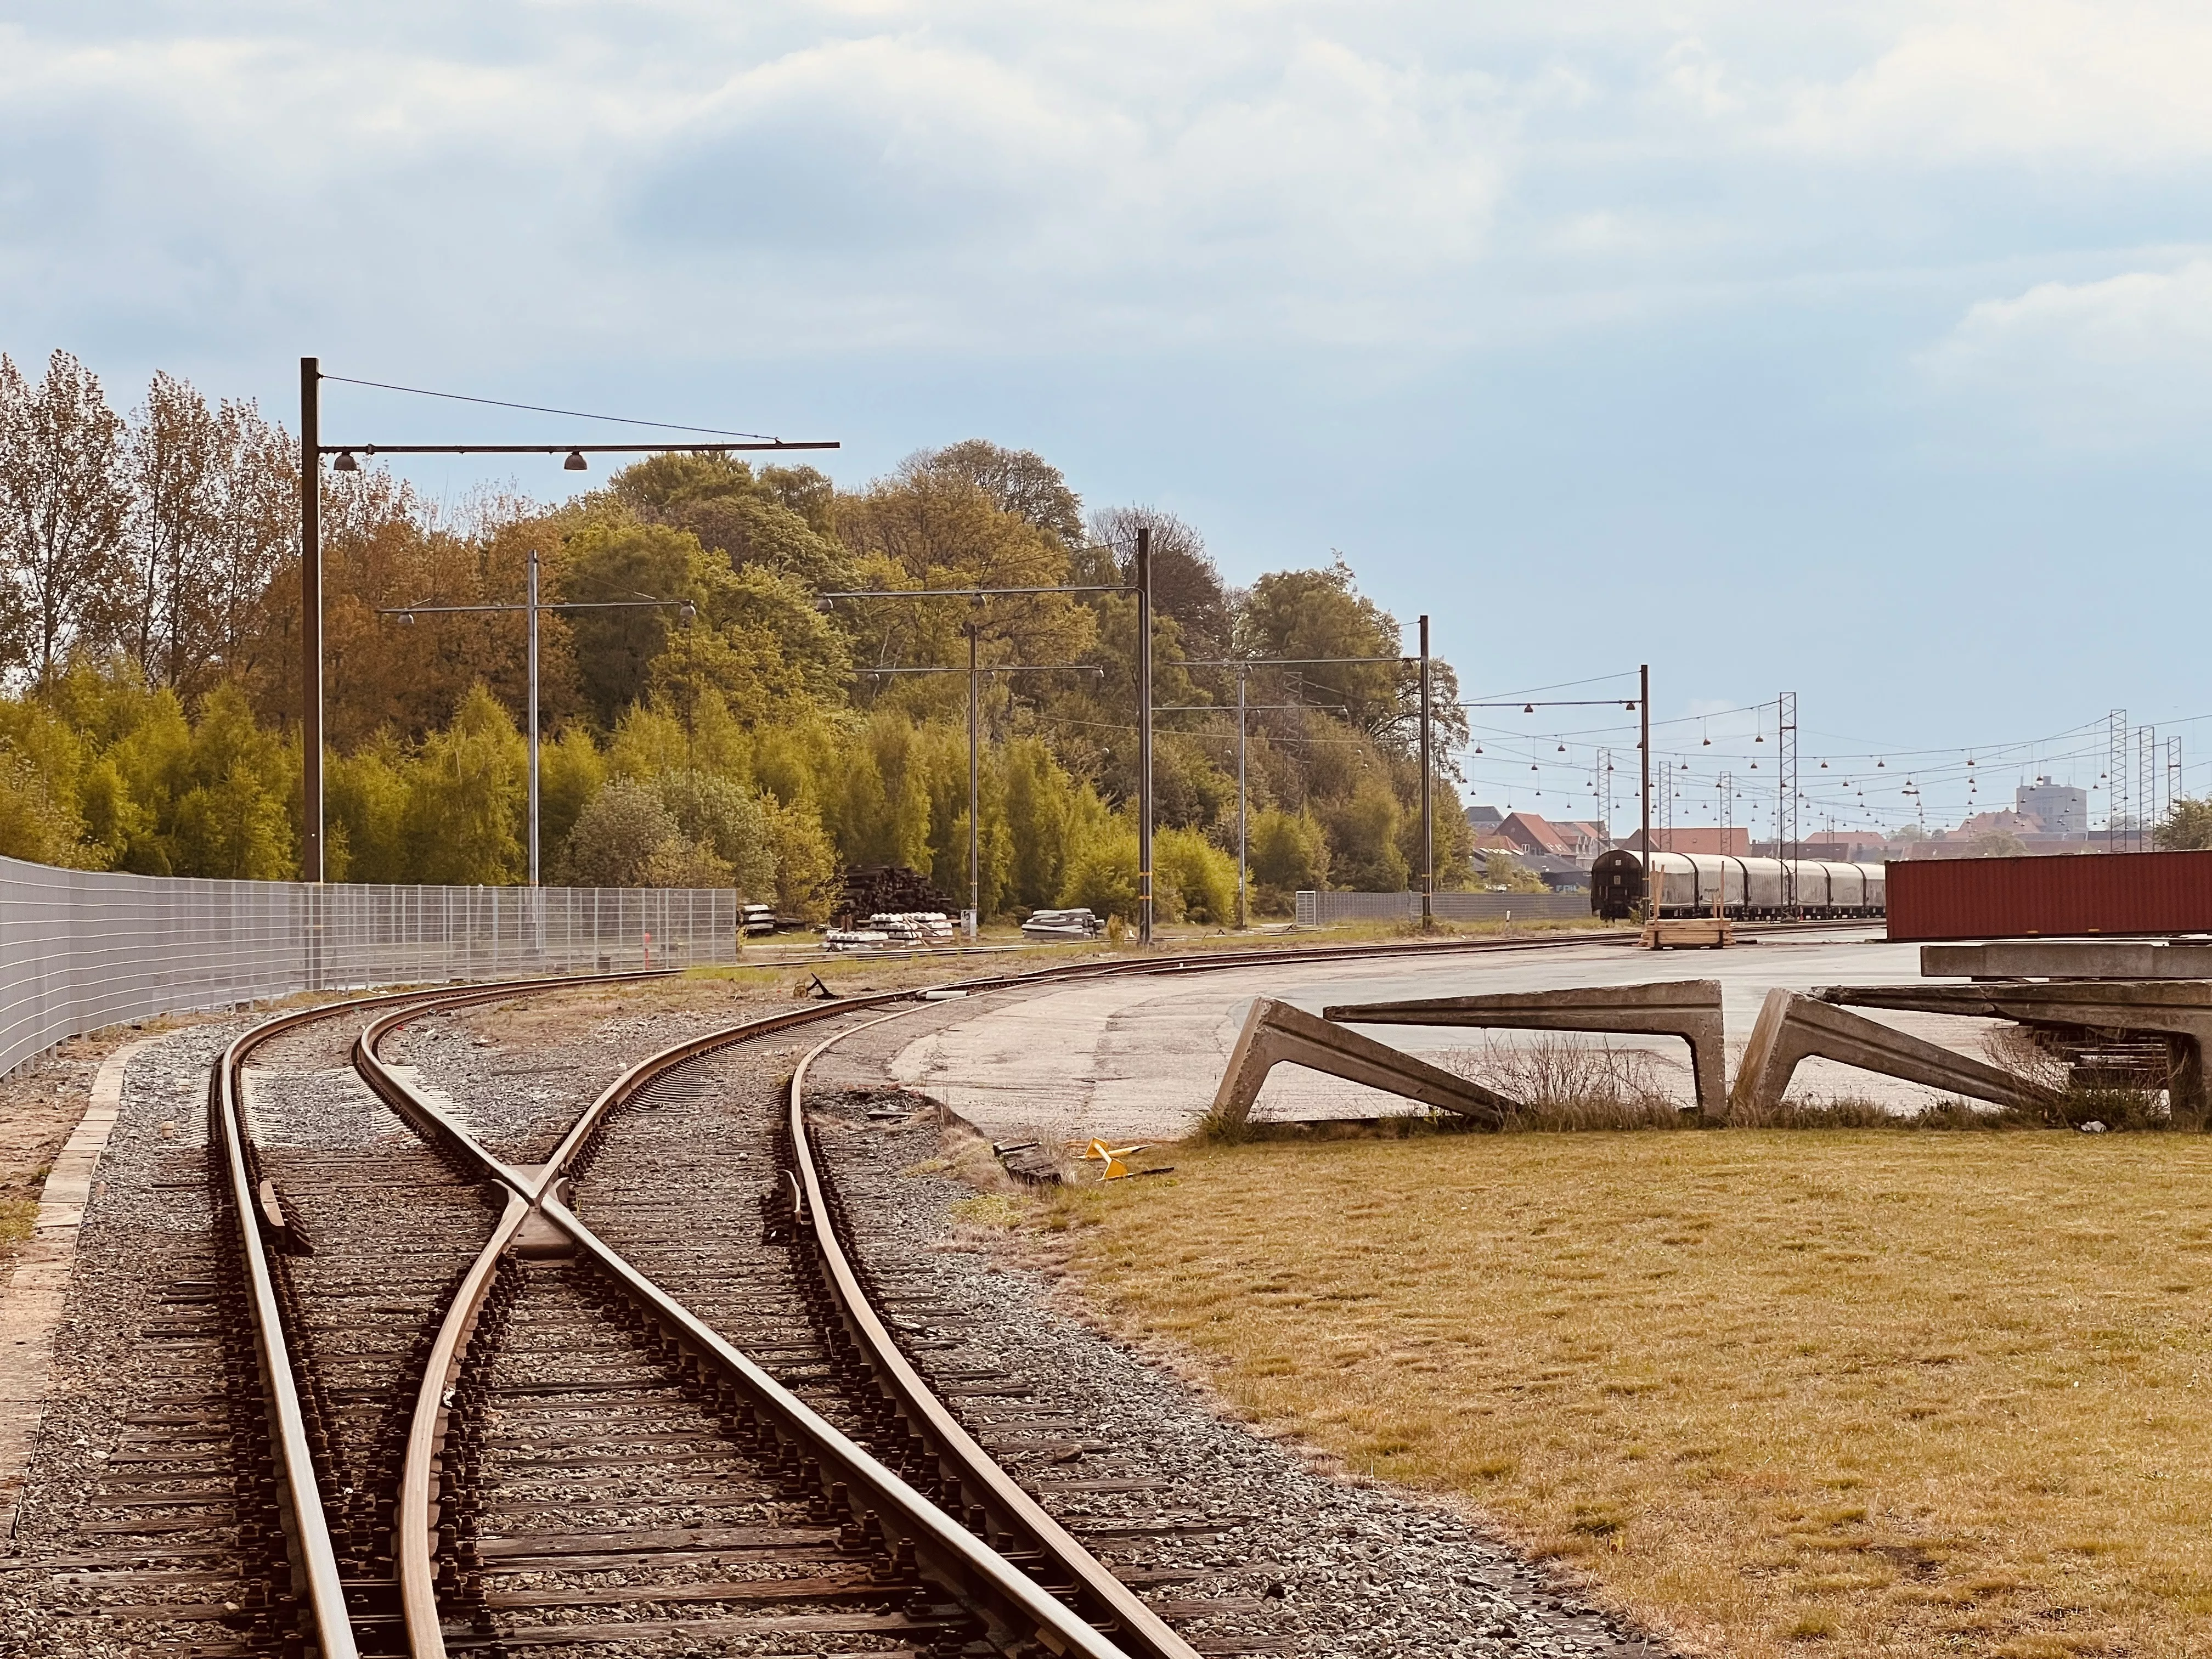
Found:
[0,858,737,1075]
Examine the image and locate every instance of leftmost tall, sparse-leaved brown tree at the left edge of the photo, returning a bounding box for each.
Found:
[0,352,131,681]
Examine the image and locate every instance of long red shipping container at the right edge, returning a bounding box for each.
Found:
[1884,851,2212,940]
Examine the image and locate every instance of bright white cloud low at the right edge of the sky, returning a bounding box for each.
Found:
[1922,259,2212,447]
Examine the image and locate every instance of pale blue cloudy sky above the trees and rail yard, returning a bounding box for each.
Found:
[0,0,2212,823]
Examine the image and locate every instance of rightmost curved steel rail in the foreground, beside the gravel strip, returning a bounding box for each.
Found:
[789,1005,1197,1659]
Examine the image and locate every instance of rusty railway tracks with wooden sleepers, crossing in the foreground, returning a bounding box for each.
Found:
[49,929,1867,1659]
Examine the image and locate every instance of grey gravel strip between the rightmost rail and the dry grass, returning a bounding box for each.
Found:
[819,1091,1672,1659]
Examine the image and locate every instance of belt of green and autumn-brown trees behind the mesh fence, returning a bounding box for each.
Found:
[0,352,1469,924]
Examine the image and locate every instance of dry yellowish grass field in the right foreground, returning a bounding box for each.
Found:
[1040,1130,2212,1659]
